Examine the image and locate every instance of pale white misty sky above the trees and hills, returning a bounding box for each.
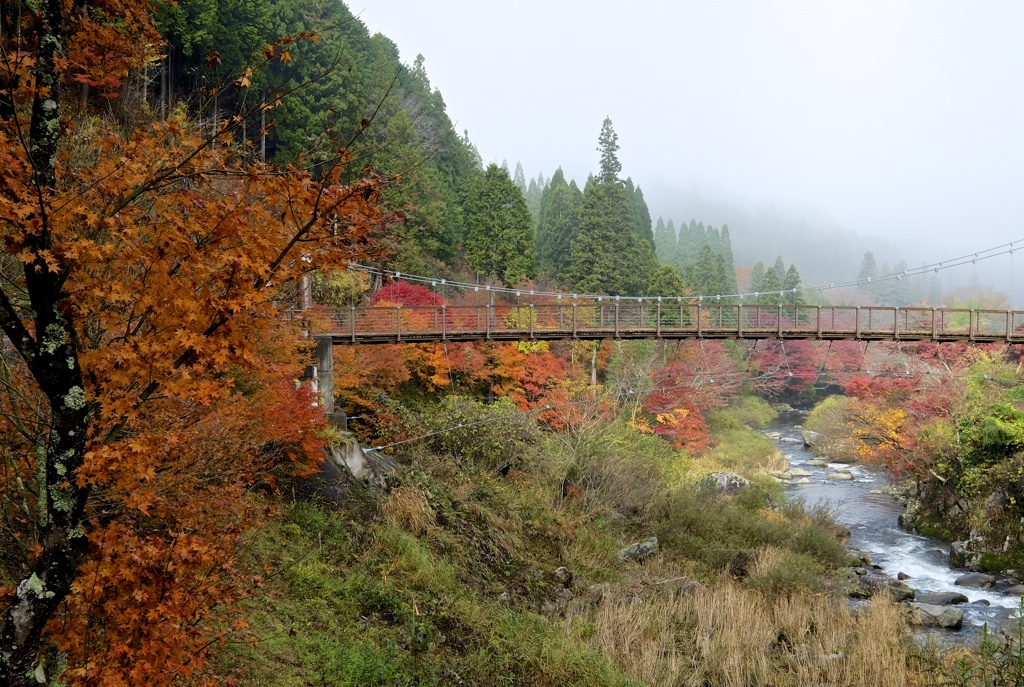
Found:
[349,0,1024,278]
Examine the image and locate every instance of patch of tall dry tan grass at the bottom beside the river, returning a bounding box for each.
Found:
[566,573,916,687]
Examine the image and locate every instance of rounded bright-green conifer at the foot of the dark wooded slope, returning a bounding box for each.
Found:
[466,165,535,285]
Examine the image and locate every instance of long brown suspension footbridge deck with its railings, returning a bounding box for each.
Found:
[309,299,1024,345]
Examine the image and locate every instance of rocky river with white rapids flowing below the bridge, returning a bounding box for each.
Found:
[768,413,1021,638]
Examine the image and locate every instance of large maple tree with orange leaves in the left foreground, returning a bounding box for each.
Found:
[0,0,384,686]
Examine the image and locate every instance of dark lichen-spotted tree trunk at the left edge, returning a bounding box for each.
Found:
[0,0,92,687]
